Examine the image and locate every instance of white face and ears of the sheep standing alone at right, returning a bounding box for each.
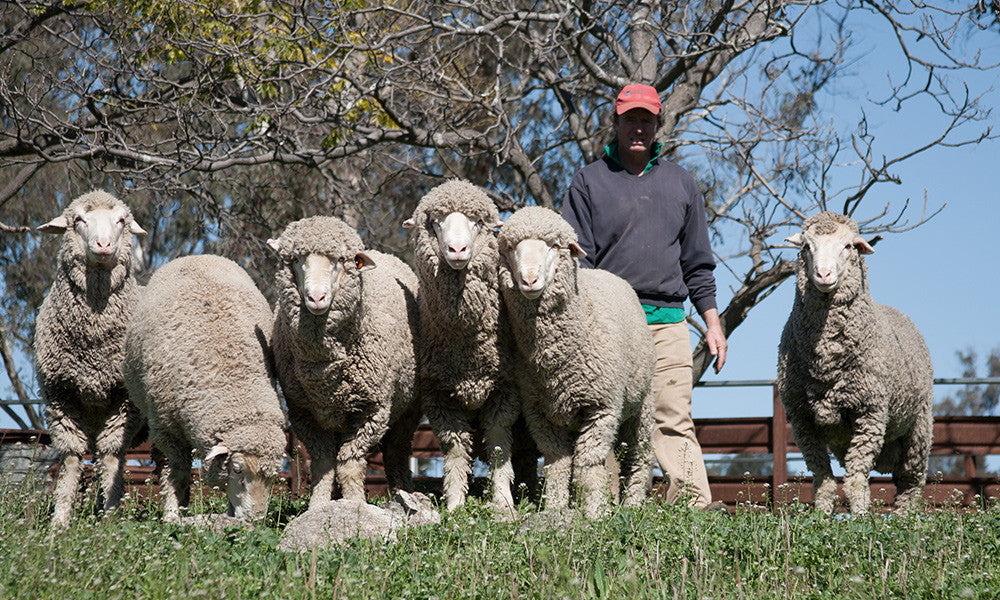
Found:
[787,225,874,294]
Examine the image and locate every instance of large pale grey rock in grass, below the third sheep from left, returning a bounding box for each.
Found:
[278,500,406,552]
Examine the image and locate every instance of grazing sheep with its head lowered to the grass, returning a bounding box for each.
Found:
[124,255,286,522]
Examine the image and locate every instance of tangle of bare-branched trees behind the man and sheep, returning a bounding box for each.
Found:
[0,0,996,426]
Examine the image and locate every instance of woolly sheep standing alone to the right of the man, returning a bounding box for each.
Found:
[778,212,933,513]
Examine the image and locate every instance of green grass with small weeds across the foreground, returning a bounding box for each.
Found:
[0,476,1000,600]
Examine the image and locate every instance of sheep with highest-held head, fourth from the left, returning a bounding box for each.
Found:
[403,180,534,510]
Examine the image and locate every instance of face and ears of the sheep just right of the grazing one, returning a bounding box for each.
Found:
[291,252,375,315]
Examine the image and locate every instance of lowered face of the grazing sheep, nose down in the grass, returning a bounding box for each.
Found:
[205,446,276,519]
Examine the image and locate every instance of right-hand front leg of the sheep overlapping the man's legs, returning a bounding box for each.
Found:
[573,412,619,519]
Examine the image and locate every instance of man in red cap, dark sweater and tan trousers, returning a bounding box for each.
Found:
[562,84,726,507]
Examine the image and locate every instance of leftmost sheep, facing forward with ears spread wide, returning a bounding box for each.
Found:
[34,191,146,528]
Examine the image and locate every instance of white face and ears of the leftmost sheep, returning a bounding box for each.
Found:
[39,204,146,269]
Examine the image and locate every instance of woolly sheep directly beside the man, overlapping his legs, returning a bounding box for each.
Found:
[498,207,656,518]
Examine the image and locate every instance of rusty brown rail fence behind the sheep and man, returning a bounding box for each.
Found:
[0,384,1000,506]
